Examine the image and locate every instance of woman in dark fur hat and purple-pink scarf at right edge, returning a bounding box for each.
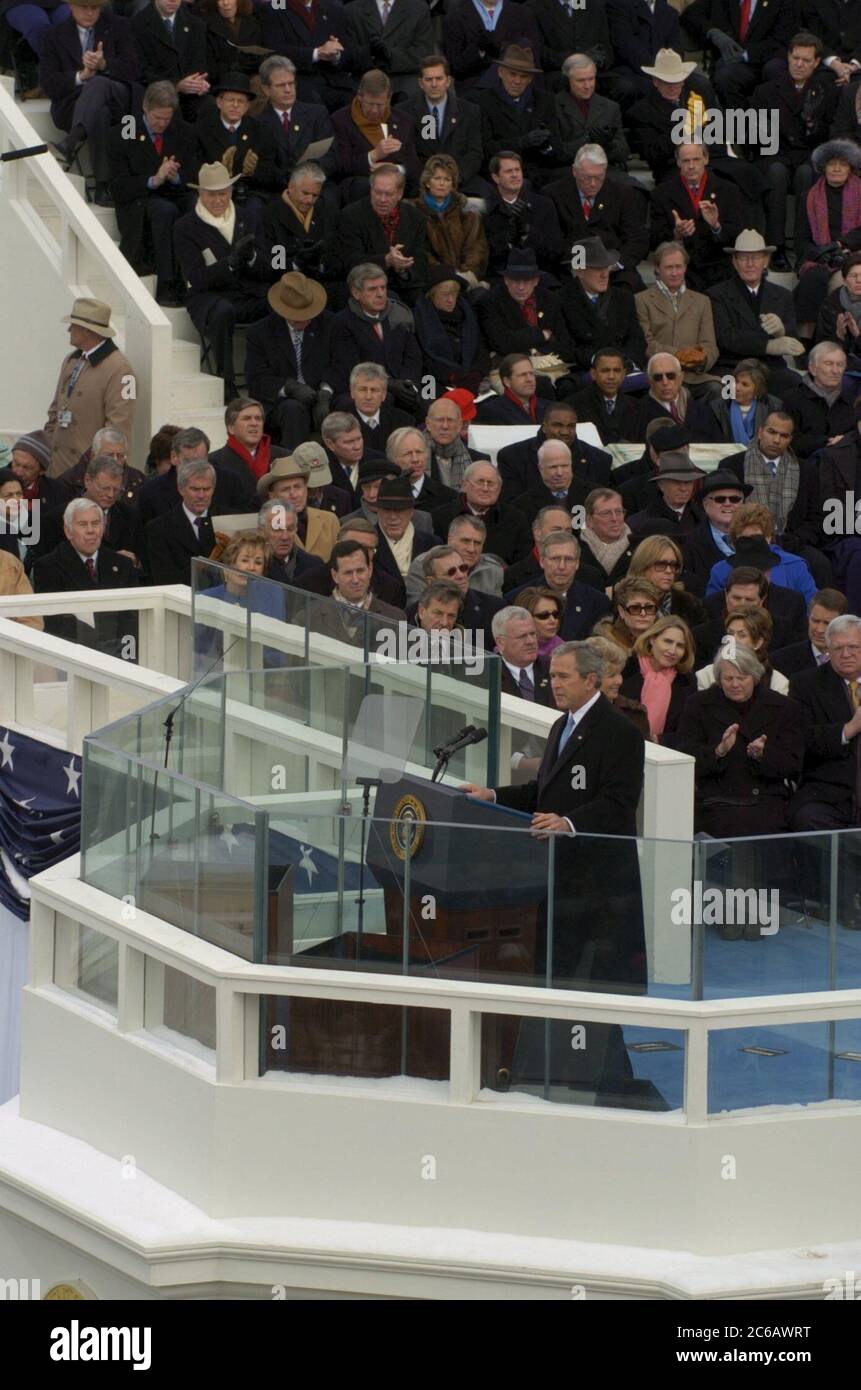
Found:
[794,140,861,338]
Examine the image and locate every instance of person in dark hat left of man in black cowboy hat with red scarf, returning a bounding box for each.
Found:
[413,265,490,396]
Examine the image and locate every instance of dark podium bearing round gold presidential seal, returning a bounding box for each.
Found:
[268,776,548,1087]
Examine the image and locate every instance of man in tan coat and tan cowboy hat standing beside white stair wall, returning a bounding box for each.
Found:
[43,299,136,478]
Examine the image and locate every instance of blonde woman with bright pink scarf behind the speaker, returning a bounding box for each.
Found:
[622,617,697,746]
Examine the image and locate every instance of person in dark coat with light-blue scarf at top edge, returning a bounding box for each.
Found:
[442,0,541,101]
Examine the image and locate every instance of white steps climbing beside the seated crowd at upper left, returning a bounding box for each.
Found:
[22,100,227,449]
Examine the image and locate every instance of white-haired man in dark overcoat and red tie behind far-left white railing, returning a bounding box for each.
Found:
[32,498,139,662]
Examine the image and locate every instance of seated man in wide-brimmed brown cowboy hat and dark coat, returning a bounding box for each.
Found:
[245,271,335,449]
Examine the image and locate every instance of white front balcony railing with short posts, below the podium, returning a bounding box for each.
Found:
[29,856,861,1125]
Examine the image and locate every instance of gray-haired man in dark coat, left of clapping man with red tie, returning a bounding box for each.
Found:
[544,143,648,293]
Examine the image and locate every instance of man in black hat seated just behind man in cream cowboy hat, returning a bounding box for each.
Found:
[195,72,279,203]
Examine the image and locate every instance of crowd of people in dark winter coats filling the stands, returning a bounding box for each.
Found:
[8,0,861,945]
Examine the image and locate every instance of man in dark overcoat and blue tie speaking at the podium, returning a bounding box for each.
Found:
[462,642,656,1105]
